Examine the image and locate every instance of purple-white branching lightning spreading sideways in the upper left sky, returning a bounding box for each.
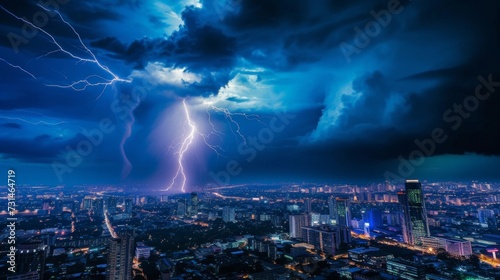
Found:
[0,4,131,91]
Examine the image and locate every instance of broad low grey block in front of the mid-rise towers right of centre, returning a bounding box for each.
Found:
[302,225,341,255]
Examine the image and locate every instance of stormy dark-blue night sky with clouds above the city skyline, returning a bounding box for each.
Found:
[0,0,500,189]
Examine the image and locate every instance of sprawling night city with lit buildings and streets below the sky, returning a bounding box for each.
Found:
[1,180,500,280]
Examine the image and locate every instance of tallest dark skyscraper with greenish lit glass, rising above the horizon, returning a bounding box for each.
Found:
[398,180,430,245]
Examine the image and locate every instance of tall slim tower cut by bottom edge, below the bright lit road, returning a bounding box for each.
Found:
[106,230,134,280]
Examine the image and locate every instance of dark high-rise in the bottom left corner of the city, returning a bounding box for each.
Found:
[12,240,48,279]
